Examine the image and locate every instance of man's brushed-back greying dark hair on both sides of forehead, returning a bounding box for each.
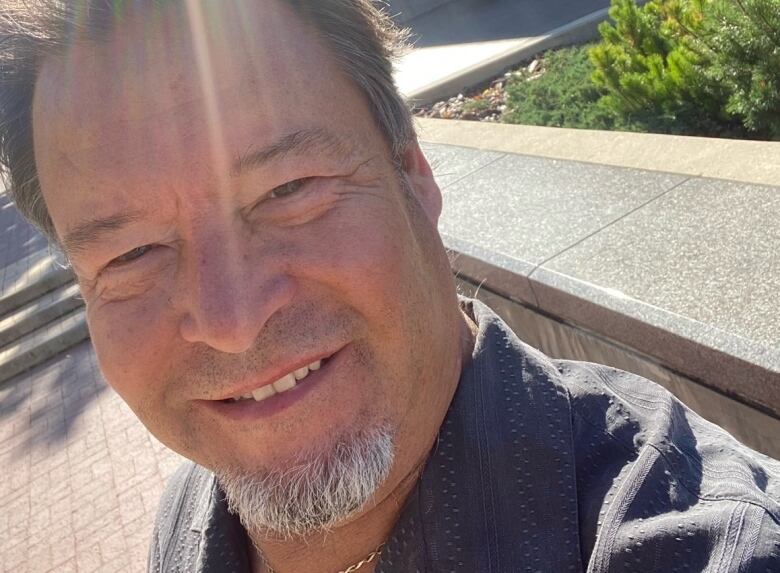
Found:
[0,0,415,243]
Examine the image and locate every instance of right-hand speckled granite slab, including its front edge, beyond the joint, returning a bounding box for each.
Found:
[531,179,780,417]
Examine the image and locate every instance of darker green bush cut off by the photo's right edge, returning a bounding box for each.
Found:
[694,0,780,140]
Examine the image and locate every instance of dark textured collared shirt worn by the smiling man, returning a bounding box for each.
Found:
[149,301,780,573]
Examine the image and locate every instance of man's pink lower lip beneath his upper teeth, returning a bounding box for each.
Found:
[197,346,347,422]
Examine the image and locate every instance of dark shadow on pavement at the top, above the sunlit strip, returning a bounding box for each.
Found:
[403,0,609,48]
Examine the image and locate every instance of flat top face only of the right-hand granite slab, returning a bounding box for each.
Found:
[545,179,780,350]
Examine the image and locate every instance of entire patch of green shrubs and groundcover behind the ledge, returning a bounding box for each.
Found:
[502,0,780,140]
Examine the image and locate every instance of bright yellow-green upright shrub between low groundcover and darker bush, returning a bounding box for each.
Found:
[590,0,735,135]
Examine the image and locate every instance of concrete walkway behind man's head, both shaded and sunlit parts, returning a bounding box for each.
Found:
[395,0,609,104]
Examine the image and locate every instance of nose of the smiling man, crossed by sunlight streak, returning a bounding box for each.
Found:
[180,229,292,354]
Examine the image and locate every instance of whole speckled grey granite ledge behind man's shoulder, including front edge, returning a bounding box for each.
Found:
[424,144,780,418]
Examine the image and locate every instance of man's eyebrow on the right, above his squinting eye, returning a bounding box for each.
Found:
[231,128,345,177]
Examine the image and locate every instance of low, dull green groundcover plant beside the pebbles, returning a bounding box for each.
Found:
[501,46,628,130]
